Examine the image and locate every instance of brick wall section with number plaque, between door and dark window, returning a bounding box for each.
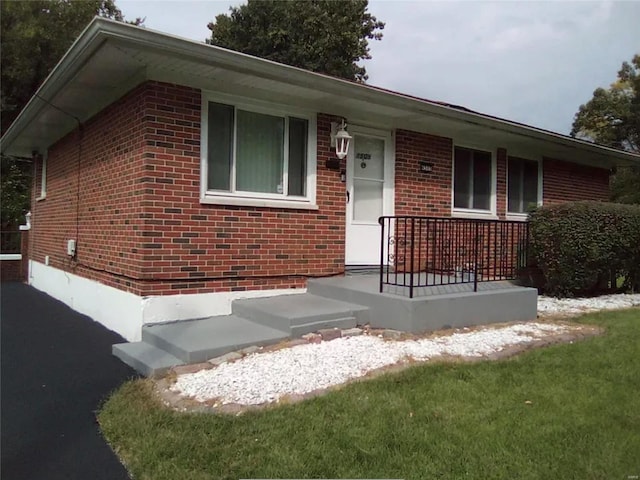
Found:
[395,130,453,216]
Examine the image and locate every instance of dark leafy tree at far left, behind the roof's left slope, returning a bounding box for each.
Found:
[0,0,143,228]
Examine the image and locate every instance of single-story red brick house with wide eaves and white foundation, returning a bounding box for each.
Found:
[2,18,640,341]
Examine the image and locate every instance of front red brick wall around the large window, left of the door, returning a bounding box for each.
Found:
[136,83,345,295]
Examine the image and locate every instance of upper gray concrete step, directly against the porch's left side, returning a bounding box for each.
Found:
[231,293,369,336]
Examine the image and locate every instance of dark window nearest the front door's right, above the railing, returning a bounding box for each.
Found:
[453,147,493,211]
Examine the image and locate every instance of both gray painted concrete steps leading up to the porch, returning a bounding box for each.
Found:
[113,294,368,377]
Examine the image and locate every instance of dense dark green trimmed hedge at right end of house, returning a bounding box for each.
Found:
[530,202,640,296]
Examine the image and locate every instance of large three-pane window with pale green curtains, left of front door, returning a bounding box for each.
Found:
[203,97,315,208]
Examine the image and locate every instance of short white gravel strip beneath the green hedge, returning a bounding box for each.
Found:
[538,293,640,315]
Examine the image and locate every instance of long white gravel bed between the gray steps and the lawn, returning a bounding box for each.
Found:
[171,323,570,405]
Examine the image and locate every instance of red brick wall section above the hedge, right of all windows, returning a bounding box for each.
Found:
[542,158,609,205]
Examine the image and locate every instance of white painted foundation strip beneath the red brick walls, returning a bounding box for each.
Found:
[29,260,307,342]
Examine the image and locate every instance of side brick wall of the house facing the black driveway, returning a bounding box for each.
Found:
[29,83,145,293]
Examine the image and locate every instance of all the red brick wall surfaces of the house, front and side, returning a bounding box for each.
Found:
[30,78,608,295]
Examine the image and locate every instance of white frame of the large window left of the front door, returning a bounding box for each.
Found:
[200,91,318,210]
